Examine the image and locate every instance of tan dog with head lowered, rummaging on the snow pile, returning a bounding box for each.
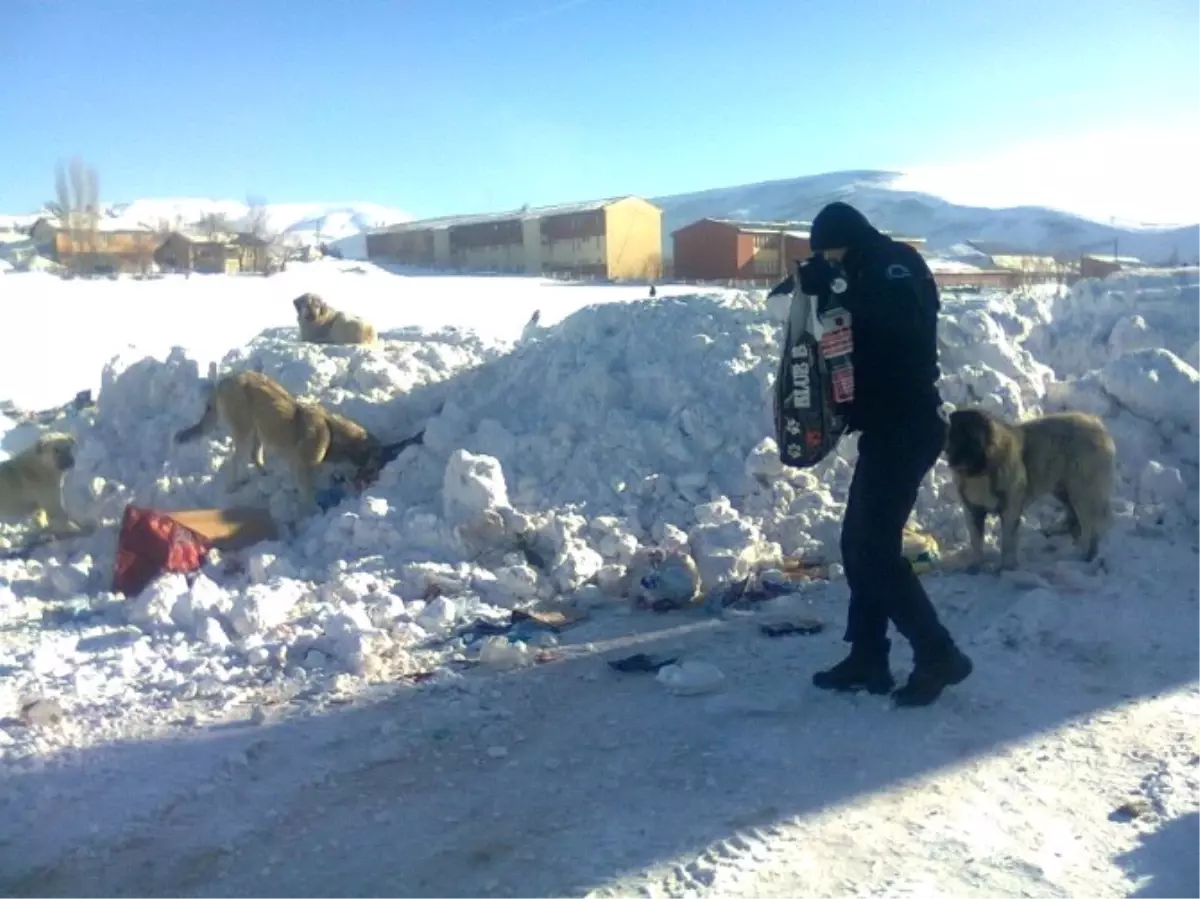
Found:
[175,371,382,505]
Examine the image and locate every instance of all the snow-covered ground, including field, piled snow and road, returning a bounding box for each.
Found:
[0,262,1200,899]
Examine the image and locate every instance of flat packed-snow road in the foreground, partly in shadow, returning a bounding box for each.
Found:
[0,539,1200,899]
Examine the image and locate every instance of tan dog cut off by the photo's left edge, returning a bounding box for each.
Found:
[0,433,80,533]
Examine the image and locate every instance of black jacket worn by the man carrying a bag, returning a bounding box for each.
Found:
[770,234,941,431]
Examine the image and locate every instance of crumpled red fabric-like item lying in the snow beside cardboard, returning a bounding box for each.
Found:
[113,505,211,597]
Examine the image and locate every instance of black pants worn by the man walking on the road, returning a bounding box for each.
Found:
[841,409,952,655]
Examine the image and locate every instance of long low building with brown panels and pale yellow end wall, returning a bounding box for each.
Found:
[367,197,662,281]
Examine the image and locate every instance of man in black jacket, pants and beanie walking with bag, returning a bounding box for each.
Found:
[776,203,972,706]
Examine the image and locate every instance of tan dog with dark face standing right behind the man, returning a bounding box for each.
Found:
[946,409,1116,570]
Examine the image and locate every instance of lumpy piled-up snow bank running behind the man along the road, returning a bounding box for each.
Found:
[0,268,1200,763]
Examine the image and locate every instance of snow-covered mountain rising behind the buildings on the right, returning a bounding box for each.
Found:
[652,170,1200,263]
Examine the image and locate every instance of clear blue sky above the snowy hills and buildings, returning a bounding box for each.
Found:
[0,0,1200,220]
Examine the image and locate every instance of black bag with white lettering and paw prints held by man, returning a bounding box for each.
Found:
[774,263,854,468]
